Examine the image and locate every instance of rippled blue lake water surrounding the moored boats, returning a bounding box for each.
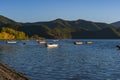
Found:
[0,40,120,80]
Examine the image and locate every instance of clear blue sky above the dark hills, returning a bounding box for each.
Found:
[0,0,120,23]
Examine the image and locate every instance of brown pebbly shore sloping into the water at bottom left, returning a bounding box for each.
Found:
[0,62,30,80]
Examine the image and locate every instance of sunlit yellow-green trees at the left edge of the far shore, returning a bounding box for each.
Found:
[0,27,41,40]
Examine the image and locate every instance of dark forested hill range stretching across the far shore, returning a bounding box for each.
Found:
[0,16,120,39]
